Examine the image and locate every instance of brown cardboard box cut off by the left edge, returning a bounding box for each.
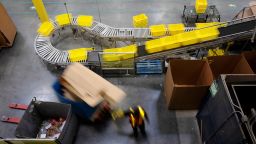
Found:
[0,3,16,48]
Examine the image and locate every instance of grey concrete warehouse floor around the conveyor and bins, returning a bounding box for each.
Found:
[0,0,252,144]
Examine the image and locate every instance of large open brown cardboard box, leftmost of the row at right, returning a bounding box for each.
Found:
[164,60,213,110]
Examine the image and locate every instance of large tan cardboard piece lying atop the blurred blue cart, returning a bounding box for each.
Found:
[60,63,126,107]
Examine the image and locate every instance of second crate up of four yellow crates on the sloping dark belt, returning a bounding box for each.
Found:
[161,35,181,50]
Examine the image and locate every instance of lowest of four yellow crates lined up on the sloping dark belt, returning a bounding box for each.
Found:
[145,38,164,53]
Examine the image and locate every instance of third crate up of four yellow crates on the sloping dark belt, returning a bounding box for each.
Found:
[177,31,199,46]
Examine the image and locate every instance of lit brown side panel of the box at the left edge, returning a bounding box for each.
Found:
[0,3,16,45]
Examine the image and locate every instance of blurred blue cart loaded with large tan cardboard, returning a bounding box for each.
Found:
[53,63,126,121]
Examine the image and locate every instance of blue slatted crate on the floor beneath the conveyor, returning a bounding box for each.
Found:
[136,60,163,74]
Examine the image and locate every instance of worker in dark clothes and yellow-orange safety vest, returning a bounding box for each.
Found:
[125,106,149,137]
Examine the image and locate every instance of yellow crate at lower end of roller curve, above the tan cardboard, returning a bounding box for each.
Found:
[68,48,94,62]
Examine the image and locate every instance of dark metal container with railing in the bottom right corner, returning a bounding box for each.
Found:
[197,75,256,144]
